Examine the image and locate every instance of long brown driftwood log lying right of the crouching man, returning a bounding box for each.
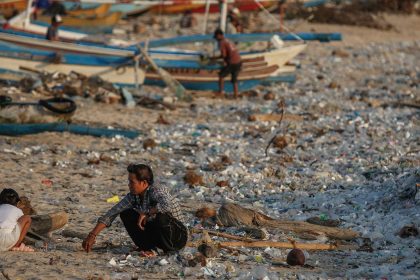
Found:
[216,203,359,240]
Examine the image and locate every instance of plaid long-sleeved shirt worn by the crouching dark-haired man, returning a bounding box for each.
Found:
[98,184,185,227]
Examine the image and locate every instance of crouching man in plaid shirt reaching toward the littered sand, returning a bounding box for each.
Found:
[82,164,188,257]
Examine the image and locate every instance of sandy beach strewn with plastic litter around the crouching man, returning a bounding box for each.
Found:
[0,9,420,280]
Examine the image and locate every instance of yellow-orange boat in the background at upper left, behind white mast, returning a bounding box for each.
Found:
[34,13,121,33]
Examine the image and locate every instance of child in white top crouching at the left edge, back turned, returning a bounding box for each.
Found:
[0,189,34,252]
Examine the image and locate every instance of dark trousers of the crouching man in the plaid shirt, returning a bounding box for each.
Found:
[120,209,188,252]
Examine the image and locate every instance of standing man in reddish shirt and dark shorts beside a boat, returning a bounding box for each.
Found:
[213,28,242,98]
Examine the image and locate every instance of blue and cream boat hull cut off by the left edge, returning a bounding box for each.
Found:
[0,34,144,85]
